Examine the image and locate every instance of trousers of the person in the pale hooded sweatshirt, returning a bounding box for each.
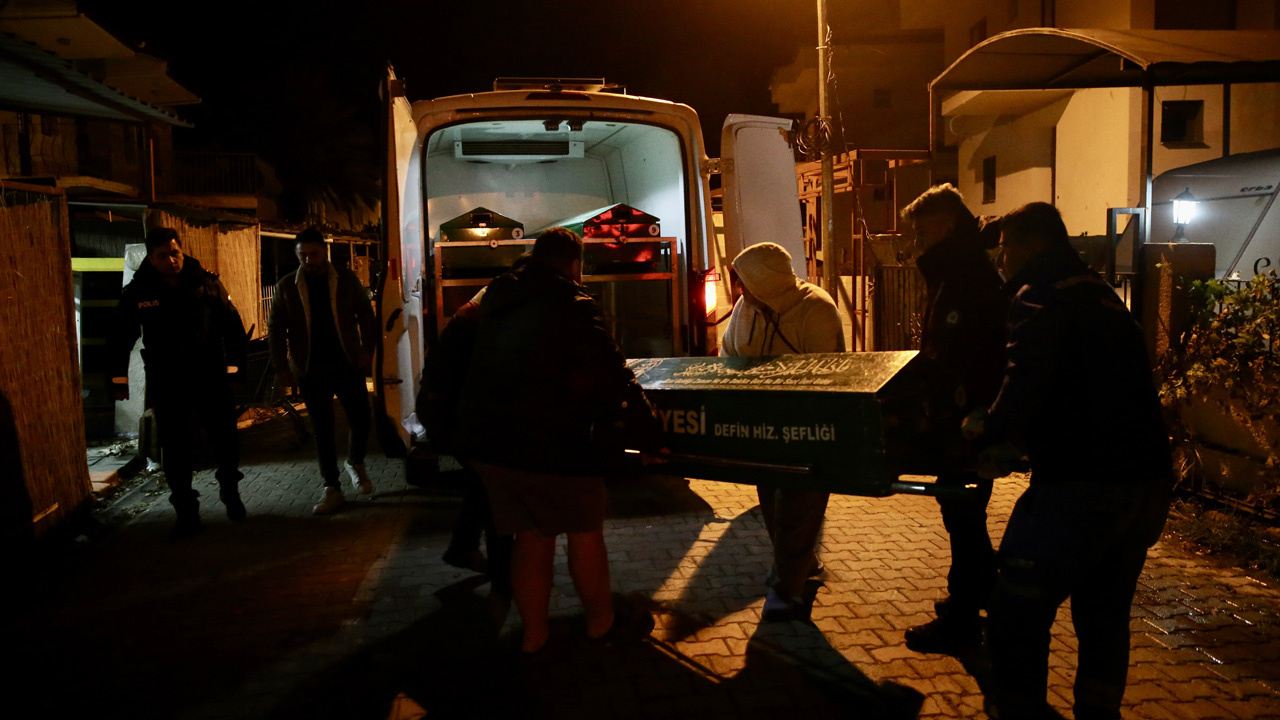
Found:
[755,484,831,600]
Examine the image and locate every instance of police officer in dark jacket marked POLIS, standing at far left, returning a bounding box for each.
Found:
[110,228,246,538]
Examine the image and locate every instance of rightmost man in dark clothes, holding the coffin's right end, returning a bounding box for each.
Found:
[966,202,1172,720]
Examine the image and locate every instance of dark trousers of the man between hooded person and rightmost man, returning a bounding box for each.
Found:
[938,473,996,621]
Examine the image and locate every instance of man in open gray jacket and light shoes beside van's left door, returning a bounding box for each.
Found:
[268,228,380,515]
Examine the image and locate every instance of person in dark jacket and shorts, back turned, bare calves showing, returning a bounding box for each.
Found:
[458,228,660,653]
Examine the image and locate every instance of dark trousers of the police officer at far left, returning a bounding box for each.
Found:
[147,373,244,510]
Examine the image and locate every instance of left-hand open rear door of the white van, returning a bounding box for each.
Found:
[374,65,425,457]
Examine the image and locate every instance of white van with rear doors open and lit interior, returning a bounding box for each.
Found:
[375,70,805,455]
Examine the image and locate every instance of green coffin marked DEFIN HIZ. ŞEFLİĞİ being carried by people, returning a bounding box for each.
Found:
[630,351,959,497]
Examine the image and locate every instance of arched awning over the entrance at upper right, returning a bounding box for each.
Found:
[929,28,1280,94]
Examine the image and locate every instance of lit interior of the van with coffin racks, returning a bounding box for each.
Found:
[424,118,690,357]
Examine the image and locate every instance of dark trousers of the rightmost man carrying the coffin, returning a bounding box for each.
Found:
[988,479,1169,720]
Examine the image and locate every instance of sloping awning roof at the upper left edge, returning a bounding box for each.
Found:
[0,33,191,127]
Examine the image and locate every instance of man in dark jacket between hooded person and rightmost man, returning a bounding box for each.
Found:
[902,184,1009,652]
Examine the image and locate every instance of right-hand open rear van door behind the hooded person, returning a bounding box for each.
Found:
[721,115,809,281]
